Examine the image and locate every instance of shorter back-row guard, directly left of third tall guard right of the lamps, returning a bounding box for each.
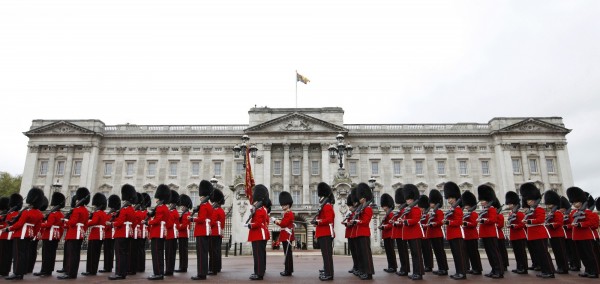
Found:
[425,189,456,276]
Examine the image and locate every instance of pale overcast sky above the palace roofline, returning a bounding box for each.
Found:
[0,0,600,196]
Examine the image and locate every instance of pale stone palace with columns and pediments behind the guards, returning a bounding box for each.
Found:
[21,107,573,252]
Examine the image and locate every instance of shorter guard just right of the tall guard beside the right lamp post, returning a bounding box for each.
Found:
[379,193,398,273]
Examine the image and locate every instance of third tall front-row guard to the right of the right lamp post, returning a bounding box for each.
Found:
[438,181,466,280]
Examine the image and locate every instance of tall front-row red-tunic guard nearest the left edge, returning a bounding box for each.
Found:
[3,187,44,280]
